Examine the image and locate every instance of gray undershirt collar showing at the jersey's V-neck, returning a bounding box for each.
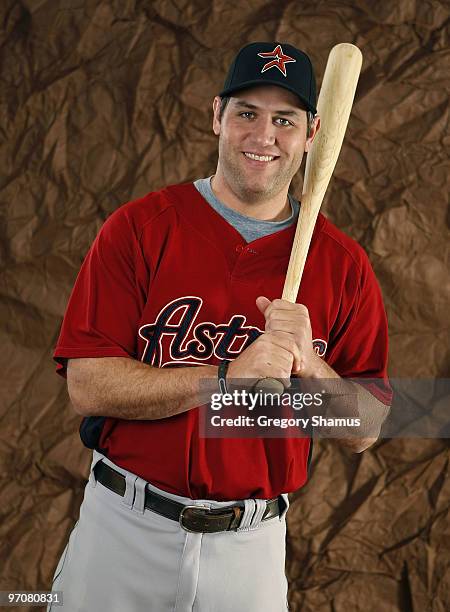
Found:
[194,176,300,242]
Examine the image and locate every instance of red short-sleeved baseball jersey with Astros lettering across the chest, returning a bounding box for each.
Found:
[54,183,390,500]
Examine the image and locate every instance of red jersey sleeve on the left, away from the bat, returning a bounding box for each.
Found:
[53,207,149,377]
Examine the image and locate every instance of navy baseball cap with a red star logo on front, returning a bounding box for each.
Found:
[219,42,317,114]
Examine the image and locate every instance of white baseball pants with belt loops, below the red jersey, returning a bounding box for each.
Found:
[47,451,289,612]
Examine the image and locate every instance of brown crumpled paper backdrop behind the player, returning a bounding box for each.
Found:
[0,0,450,612]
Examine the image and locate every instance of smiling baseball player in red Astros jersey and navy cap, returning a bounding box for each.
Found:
[52,42,389,612]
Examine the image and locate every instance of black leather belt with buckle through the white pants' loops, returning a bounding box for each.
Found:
[94,461,284,533]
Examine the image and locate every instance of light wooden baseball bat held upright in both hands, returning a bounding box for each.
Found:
[253,43,362,393]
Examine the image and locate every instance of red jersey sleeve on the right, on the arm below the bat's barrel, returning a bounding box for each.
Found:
[327,249,392,404]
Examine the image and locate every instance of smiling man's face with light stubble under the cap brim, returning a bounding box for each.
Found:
[213,85,314,203]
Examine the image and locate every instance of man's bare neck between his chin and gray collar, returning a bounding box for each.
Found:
[211,173,291,221]
